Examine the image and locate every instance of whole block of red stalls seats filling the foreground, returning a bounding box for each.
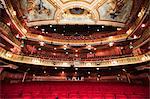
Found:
[0,81,149,99]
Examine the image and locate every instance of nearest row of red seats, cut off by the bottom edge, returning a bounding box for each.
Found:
[1,94,149,99]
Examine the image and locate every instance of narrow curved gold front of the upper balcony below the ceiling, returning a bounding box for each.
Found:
[27,33,127,45]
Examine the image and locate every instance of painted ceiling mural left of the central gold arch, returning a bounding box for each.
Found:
[21,0,56,22]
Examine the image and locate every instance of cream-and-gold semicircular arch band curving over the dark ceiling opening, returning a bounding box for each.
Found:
[54,1,100,21]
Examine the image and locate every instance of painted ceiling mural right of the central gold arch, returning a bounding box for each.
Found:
[98,0,133,22]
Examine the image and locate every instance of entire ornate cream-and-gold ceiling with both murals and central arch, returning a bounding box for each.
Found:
[20,0,133,27]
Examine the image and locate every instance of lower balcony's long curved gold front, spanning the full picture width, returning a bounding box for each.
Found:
[0,48,150,67]
